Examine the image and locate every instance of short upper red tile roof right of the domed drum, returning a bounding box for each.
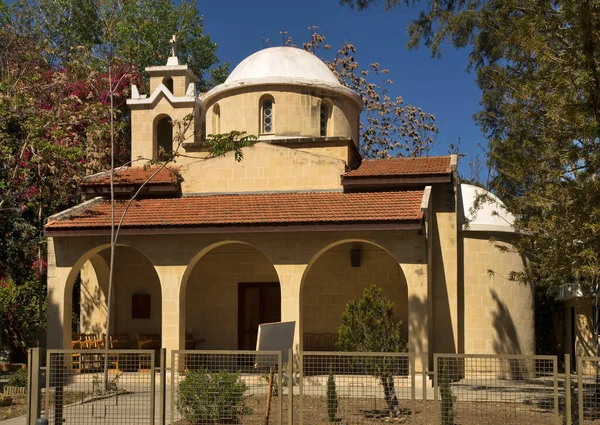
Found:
[343,156,452,178]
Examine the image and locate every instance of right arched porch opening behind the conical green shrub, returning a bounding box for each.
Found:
[300,242,409,351]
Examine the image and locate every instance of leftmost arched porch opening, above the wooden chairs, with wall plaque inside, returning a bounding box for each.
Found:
[63,246,162,348]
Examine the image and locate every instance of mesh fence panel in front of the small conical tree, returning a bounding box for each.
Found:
[299,352,416,425]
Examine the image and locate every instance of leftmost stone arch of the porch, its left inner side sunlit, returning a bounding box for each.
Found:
[62,244,162,348]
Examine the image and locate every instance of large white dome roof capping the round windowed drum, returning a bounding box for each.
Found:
[204,47,362,108]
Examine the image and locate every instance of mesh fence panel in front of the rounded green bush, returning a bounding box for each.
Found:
[170,351,286,425]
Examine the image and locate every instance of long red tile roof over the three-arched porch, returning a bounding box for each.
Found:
[46,190,423,230]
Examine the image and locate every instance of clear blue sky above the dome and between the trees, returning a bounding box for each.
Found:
[198,0,485,177]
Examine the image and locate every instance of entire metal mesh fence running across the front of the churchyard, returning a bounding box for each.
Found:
[21,350,600,425]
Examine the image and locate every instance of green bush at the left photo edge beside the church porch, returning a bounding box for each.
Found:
[0,278,46,361]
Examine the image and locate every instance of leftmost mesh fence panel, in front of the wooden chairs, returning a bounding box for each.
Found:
[45,350,156,425]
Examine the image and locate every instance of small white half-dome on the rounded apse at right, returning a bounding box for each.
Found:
[459,184,515,232]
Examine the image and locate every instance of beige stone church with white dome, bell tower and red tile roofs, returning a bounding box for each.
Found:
[45,47,535,363]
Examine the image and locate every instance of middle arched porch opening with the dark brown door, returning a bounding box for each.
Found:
[180,242,281,350]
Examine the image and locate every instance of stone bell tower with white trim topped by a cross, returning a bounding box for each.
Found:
[127,35,201,166]
